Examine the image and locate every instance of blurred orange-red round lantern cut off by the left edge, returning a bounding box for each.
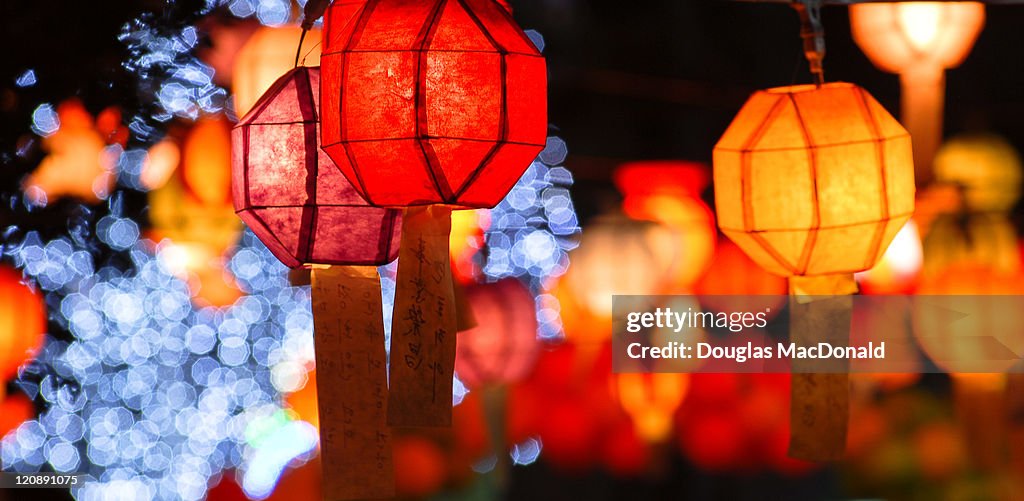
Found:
[0,265,46,377]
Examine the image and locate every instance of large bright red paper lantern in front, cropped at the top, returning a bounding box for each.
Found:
[322,0,547,207]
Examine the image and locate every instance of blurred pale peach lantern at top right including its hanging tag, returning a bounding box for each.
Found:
[850,2,985,184]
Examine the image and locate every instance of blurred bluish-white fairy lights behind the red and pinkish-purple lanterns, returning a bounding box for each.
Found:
[0,0,580,500]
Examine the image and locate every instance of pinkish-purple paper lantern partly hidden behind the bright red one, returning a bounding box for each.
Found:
[231,68,401,267]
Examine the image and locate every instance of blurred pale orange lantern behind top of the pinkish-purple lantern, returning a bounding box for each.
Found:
[231,26,321,117]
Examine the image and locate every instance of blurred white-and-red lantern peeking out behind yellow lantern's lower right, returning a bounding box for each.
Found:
[855,219,925,294]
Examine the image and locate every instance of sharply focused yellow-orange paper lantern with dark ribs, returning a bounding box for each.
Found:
[715,83,914,277]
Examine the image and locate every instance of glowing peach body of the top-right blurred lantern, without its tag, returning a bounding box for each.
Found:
[850,2,985,73]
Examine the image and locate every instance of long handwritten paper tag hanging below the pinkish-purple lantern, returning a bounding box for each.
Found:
[312,266,394,500]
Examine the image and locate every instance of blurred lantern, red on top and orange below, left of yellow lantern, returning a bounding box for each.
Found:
[614,161,716,292]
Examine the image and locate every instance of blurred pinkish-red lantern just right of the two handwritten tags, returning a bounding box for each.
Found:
[456,278,540,388]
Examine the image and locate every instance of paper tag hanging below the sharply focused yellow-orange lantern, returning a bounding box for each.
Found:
[790,284,853,461]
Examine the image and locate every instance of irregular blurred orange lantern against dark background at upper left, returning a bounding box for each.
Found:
[23,98,119,205]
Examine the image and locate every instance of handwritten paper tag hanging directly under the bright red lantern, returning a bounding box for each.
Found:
[387,206,458,426]
